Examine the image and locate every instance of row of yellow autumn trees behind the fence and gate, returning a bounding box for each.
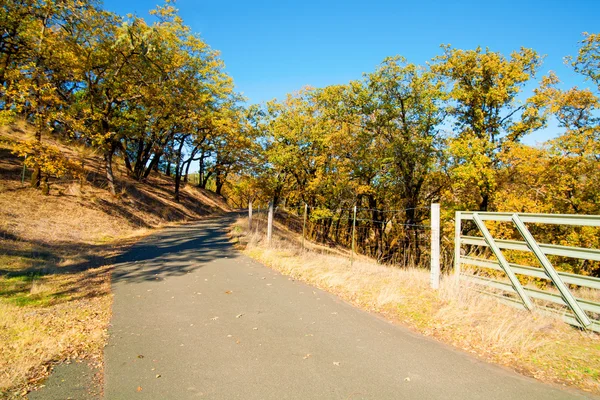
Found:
[227,34,600,277]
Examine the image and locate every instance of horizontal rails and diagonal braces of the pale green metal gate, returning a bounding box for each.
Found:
[454,211,600,332]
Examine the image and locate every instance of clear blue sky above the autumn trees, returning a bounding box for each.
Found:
[104,0,600,144]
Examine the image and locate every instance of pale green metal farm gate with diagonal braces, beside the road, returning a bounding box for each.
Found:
[454,212,600,332]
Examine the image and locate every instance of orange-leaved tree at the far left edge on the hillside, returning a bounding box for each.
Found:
[0,0,95,193]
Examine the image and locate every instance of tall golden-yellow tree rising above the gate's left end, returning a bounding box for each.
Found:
[432,46,545,211]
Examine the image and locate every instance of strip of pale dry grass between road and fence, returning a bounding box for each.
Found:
[233,219,600,393]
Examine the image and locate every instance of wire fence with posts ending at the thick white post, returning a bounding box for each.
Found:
[248,203,440,289]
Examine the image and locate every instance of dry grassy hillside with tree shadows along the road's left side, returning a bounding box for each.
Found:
[0,125,229,398]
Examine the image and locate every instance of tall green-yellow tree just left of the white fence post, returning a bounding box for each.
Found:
[366,57,445,259]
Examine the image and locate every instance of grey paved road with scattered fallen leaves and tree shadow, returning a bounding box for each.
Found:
[105,217,584,400]
